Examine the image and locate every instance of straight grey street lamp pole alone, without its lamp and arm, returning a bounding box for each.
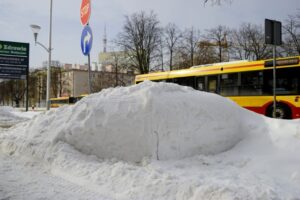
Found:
[46,0,53,110]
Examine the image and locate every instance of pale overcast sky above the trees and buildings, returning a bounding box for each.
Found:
[0,0,300,67]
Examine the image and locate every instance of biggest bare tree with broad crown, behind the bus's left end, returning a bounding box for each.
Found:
[118,12,161,73]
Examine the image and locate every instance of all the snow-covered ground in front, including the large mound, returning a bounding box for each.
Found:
[0,82,300,200]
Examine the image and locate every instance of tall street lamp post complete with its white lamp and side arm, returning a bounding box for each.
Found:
[30,0,53,110]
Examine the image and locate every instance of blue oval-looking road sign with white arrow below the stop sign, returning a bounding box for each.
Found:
[81,25,93,56]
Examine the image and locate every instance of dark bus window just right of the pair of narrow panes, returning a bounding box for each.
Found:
[220,73,239,96]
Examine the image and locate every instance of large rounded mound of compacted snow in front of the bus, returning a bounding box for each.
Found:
[1,82,244,162]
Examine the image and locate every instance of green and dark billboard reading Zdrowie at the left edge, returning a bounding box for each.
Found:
[0,41,29,79]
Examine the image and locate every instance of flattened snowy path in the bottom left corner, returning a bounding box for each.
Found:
[0,154,108,200]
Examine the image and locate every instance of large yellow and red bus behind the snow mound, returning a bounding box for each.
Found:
[135,56,300,119]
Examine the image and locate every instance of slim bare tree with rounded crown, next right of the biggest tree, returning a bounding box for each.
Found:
[165,23,182,70]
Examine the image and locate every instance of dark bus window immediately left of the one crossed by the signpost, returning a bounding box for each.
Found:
[240,71,263,96]
